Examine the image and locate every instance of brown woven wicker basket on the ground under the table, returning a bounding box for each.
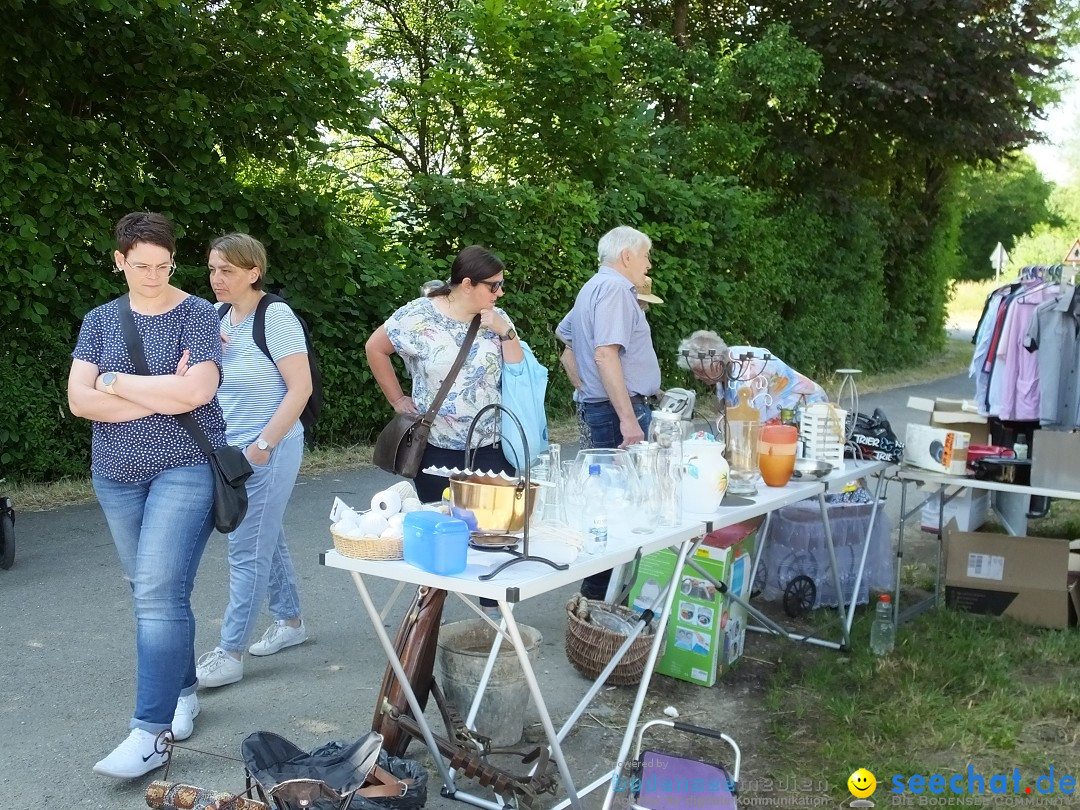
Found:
[566,594,656,686]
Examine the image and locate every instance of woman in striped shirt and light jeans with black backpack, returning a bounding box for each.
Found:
[198,233,312,688]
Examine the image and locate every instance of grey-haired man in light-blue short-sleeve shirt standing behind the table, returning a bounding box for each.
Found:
[555,226,660,599]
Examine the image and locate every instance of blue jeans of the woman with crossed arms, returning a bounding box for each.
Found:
[93,464,214,734]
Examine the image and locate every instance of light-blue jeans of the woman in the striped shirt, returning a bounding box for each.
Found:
[219,433,303,652]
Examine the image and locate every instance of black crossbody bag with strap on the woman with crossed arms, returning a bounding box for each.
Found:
[117,294,254,535]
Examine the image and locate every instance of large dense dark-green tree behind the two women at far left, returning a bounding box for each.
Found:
[0,0,371,478]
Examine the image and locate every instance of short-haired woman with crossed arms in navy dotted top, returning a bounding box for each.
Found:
[68,213,226,779]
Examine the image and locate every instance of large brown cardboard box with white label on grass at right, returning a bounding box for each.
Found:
[945,522,1080,629]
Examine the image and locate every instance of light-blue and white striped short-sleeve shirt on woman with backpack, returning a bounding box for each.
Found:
[217,301,308,447]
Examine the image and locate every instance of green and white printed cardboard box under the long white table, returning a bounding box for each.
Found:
[630,523,757,686]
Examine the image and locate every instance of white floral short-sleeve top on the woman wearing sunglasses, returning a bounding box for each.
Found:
[383,298,510,450]
